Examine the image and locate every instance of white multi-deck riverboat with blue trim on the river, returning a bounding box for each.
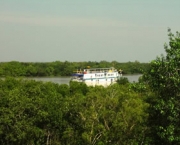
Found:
[71,67,122,87]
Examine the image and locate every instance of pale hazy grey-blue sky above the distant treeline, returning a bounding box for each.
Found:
[0,0,180,62]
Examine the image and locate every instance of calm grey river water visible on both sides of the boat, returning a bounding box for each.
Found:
[27,75,141,85]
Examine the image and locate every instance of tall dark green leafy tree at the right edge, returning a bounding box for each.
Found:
[143,29,180,144]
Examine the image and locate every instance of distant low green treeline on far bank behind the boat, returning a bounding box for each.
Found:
[0,61,149,77]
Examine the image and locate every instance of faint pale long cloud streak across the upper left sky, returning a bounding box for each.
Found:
[0,14,130,27]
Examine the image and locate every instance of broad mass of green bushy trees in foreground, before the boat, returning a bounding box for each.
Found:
[0,78,149,145]
